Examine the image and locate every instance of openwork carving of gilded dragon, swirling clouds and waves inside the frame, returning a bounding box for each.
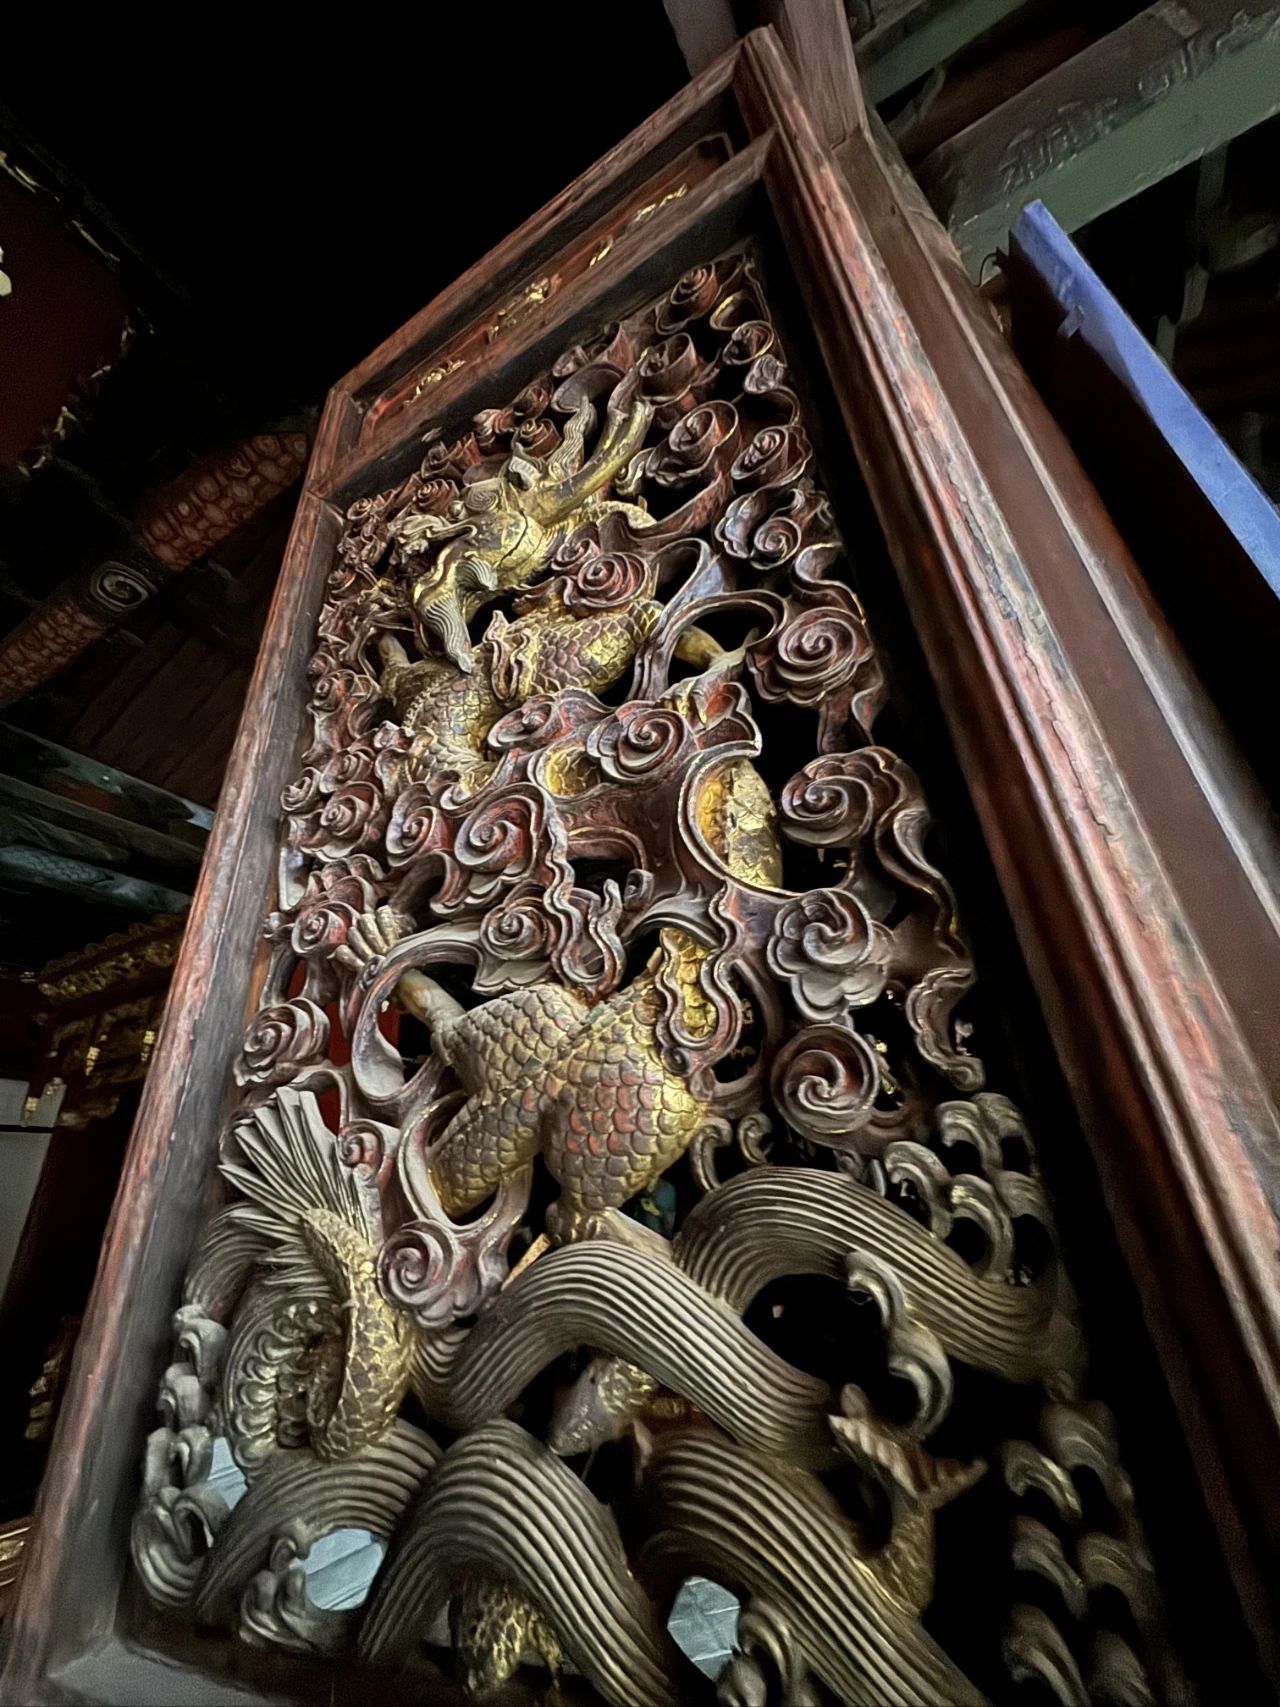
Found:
[135,253,1181,1707]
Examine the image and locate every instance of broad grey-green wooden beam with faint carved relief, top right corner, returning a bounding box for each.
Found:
[918,0,1280,277]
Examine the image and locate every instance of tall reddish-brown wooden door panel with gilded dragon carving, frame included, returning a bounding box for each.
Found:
[5,31,1277,1707]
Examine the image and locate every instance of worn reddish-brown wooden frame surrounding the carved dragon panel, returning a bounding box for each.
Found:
[3,31,1280,1702]
